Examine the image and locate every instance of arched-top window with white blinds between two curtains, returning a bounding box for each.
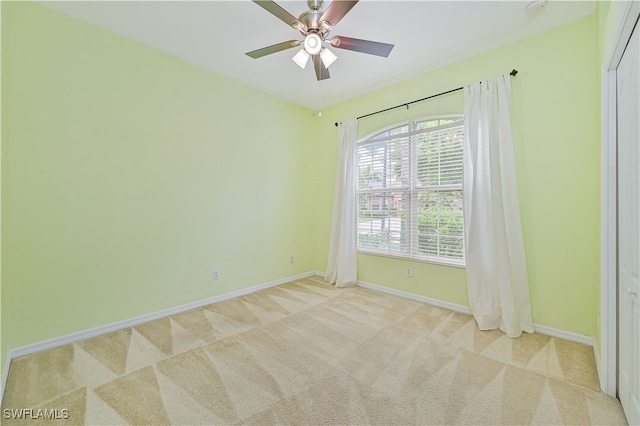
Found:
[356,116,464,266]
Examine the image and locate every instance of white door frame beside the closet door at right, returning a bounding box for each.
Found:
[595,1,640,397]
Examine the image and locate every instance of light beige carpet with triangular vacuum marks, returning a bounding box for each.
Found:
[2,277,625,425]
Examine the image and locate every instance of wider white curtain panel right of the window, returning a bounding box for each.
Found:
[463,74,533,338]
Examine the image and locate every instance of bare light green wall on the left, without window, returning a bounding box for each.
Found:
[1,2,315,372]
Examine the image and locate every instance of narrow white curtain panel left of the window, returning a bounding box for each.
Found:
[325,118,358,287]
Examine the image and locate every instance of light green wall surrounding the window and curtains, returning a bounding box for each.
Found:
[316,15,600,336]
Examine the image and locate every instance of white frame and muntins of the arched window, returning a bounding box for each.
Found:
[355,114,466,268]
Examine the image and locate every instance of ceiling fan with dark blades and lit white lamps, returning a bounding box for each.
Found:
[246,0,393,80]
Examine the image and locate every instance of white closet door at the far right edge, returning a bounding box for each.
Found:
[616,17,640,425]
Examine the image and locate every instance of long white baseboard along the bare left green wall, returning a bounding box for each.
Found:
[0,271,317,401]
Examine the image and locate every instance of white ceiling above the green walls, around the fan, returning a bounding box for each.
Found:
[41,0,596,109]
